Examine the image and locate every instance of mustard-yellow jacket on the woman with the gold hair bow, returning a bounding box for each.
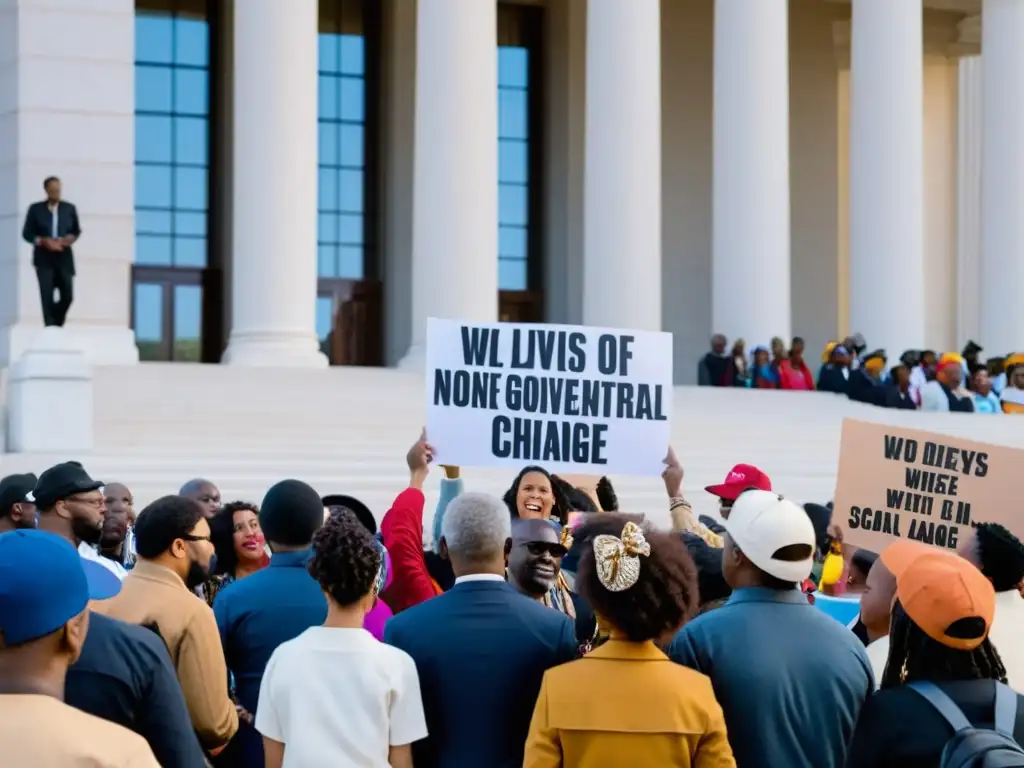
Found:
[523,640,736,768]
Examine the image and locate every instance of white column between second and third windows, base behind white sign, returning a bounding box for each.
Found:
[399,0,498,370]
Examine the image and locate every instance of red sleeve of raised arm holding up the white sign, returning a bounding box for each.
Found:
[381,488,441,613]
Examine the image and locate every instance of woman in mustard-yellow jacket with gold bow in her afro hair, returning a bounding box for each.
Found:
[523,513,736,768]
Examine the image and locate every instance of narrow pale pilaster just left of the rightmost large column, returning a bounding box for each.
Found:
[955,56,978,353]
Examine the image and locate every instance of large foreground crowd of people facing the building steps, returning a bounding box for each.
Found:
[0,434,1024,768]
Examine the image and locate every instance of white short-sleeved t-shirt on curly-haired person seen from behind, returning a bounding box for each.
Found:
[256,627,427,768]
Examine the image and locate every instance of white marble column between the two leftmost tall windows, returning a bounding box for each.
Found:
[224,0,327,368]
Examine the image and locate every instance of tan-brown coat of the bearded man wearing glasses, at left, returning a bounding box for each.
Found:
[95,558,239,750]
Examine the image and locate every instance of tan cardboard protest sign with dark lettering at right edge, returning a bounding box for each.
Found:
[833,419,1024,552]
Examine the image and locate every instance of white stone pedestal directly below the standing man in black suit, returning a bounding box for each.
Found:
[7,328,93,455]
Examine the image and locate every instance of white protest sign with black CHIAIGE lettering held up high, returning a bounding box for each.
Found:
[426,317,673,475]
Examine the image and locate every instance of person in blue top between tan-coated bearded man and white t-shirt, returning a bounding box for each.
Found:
[213,480,327,766]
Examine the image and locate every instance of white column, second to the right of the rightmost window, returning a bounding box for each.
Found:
[712,0,791,344]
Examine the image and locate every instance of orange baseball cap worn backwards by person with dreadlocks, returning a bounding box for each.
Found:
[896,552,995,650]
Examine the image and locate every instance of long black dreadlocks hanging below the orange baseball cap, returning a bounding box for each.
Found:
[879,600,1007,690]
